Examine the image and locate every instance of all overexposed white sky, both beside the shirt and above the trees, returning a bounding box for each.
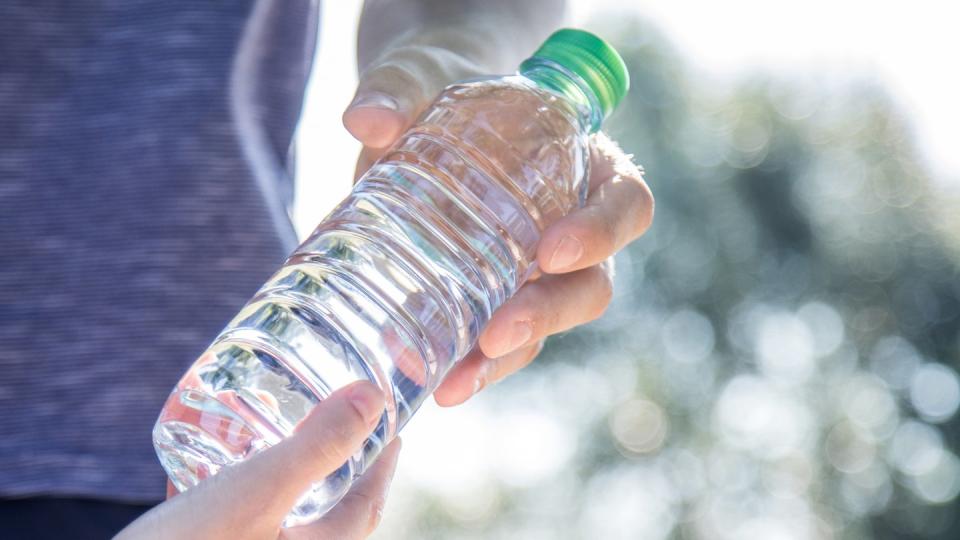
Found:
[295,0,960,234]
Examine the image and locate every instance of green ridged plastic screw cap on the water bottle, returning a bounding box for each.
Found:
[533,28,630,118]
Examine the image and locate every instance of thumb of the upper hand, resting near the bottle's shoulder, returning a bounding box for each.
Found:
[343,45,482,148]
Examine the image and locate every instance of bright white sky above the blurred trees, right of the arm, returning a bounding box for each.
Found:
[584,0,960,185]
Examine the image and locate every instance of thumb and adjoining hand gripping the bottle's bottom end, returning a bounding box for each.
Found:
[117,382,384,540]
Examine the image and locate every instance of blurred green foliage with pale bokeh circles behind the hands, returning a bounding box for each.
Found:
[381,14,960,539]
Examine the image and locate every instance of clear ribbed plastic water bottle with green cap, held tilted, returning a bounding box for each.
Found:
[154,29,628,525]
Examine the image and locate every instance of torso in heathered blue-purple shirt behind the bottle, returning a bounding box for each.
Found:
[0,0,318,499]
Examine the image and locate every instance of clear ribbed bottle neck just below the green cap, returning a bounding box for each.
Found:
[520,56,604,133]
